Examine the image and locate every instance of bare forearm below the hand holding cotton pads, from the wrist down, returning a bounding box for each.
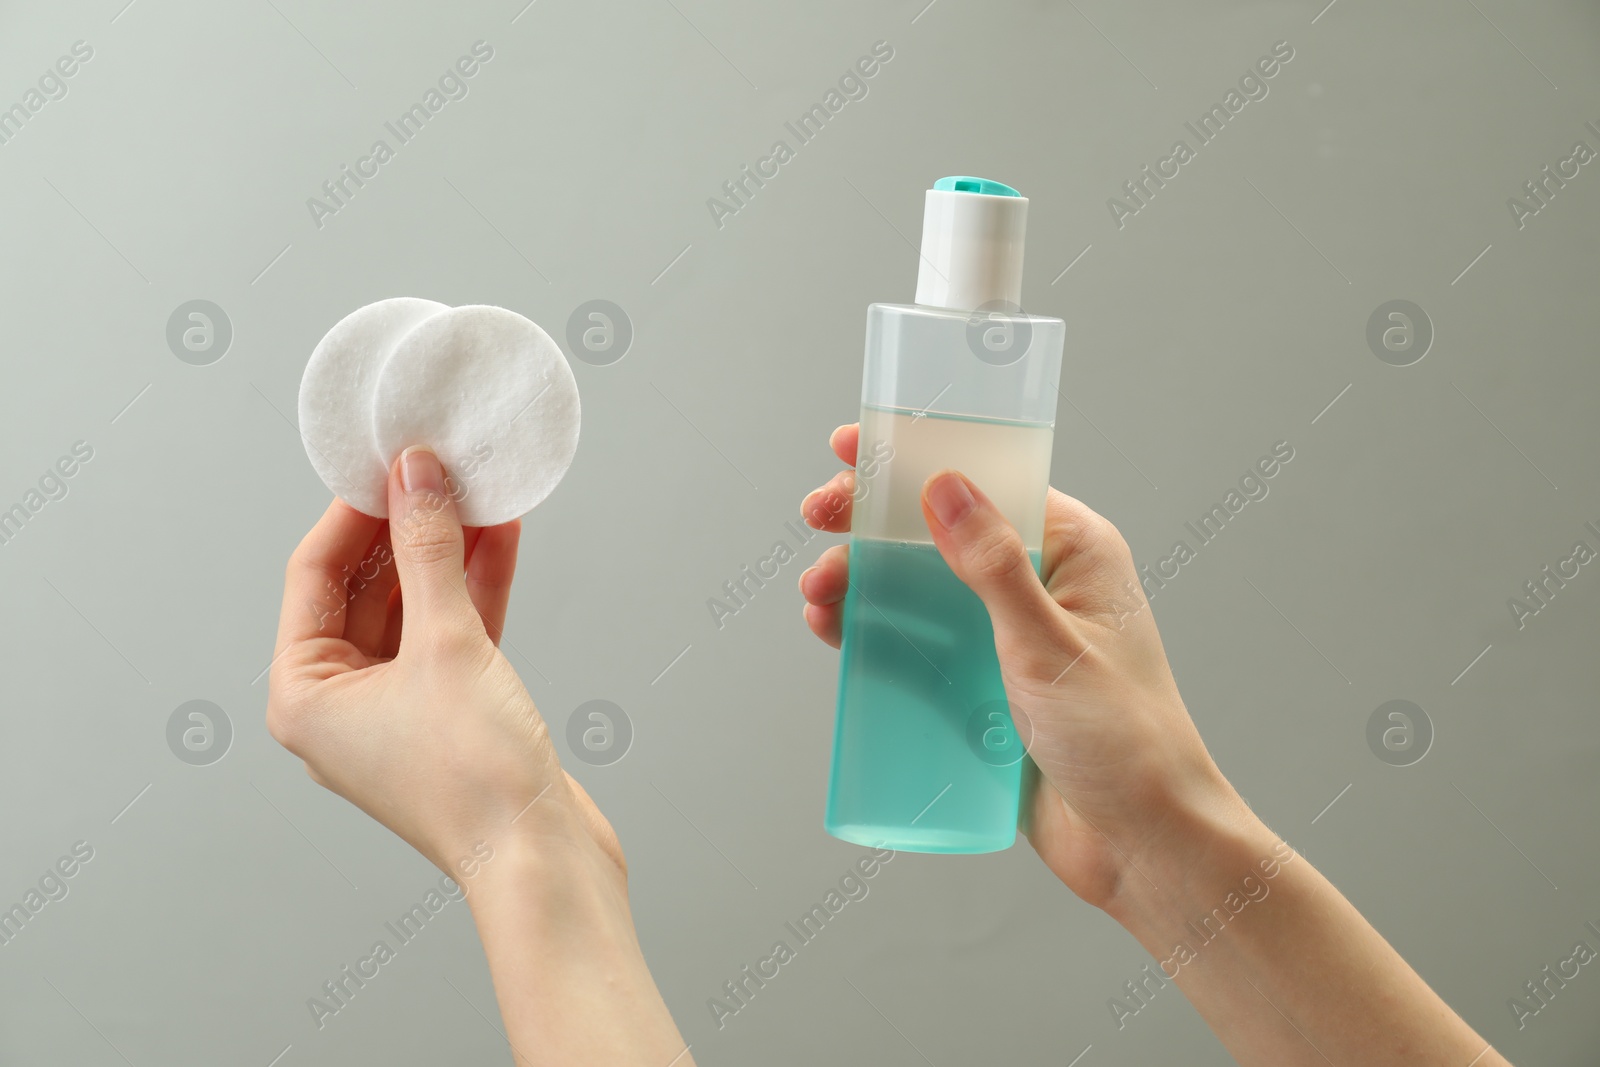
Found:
[467,841,694,1067]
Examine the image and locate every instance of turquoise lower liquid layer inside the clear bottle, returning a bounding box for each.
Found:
[826,536,1038,853]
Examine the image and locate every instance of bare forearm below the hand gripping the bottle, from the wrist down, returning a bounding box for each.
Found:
[1107,790,1506,1067]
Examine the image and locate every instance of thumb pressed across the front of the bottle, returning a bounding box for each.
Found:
[922,470,1061,643]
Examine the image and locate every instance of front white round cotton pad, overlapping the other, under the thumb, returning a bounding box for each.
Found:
[371,304,579,526]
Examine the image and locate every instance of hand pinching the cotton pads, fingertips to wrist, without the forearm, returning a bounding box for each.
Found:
[267,450,624,888]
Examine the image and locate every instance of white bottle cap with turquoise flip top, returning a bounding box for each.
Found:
[917,178,1027,310]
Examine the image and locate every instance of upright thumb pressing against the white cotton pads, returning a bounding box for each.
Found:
[389,445,477,640]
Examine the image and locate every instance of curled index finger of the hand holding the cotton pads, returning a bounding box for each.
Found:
[272,499,384,659]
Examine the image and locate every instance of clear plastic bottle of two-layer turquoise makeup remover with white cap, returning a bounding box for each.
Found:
[826,178,1066,853]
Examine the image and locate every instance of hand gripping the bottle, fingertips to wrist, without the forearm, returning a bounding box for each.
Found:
[800,426,1253,907]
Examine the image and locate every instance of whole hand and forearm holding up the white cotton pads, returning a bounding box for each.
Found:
[267,450,693,1067]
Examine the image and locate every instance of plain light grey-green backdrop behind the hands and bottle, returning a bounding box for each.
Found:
[0,0,1600,1067]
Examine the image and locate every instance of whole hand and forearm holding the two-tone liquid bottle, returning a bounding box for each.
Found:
[800,426,1507,1067]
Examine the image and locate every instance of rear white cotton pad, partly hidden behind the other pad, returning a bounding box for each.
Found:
[299,296,450,518]
